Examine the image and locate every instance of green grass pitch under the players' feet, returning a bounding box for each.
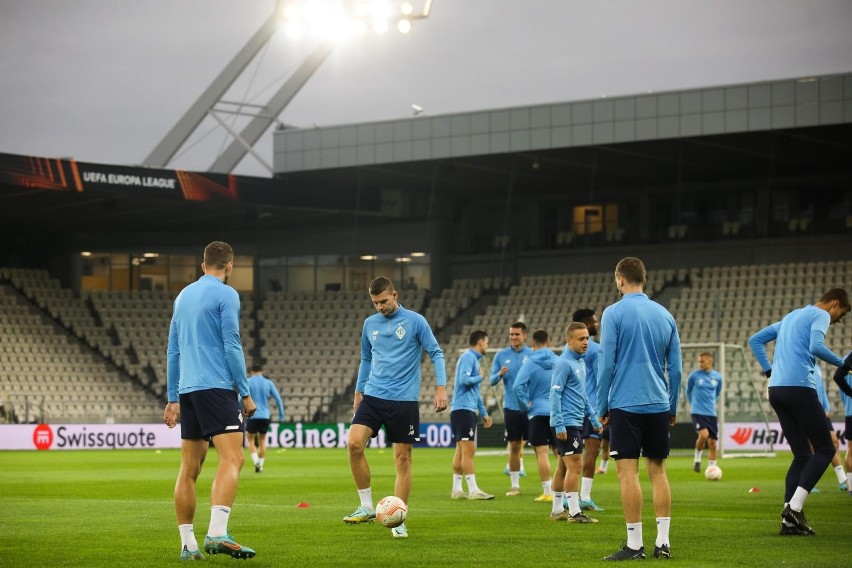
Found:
[0,449,852,568]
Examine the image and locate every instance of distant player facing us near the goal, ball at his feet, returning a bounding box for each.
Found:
[686,351,722,472]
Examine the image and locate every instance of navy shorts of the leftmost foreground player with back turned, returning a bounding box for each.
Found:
[180,389,245,440]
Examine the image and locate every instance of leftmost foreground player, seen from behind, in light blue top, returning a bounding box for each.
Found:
[163,241,256,560]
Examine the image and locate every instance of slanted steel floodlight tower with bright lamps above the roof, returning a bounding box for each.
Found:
[143,0,432,173]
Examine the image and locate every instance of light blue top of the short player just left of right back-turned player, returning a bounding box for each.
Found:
[550,349,601,434]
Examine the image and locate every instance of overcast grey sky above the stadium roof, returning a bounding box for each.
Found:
[0,0,852,176]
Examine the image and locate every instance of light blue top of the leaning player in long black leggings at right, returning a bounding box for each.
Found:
[748,305,843,389]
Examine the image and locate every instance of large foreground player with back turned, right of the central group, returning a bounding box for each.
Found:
[598,257,683,560]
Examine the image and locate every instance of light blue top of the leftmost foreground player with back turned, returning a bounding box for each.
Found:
[166,274,249,402]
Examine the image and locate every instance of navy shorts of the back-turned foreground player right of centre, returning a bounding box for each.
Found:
[609,408,670,460]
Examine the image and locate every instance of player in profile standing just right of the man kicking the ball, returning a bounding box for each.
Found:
[450,330,494,501]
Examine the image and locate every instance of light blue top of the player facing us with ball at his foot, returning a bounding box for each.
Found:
[355,304,447,401]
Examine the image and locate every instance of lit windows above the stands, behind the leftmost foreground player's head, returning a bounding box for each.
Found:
[80,252,254,293]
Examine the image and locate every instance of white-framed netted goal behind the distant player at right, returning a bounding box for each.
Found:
[678,343,780,457]
